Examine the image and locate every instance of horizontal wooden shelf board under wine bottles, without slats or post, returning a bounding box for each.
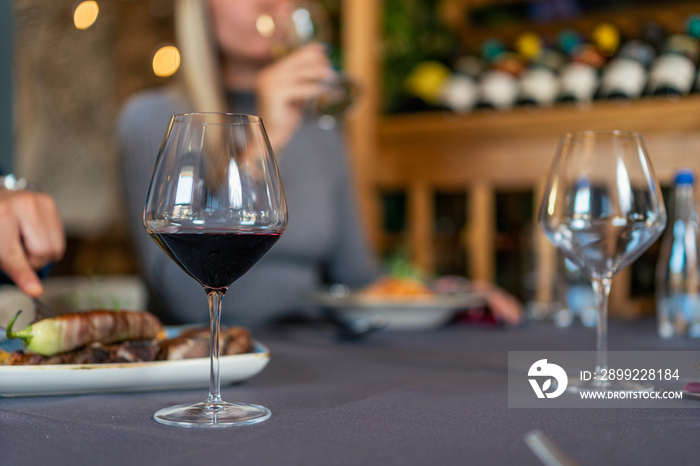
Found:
[372,96,700,187]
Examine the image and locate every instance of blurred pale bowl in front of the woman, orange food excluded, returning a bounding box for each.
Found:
[311,292,485,331]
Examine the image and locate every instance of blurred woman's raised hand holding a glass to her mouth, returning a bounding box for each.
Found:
[256,43,335,153]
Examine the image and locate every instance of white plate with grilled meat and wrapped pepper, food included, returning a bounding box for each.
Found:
[0,310,270,397]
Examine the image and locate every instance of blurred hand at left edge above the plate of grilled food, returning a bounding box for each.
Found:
[0,190,66,297]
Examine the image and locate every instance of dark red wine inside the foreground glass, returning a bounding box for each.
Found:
[151,231,280,290]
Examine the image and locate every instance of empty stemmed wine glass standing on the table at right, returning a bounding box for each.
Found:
[539,131,666,390]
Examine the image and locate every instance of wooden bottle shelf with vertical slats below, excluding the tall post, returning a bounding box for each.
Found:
[378,96,700,314]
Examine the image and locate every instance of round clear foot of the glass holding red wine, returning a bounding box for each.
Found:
[153,401,272,428]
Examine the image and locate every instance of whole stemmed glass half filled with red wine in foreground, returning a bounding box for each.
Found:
[144,113,287,427]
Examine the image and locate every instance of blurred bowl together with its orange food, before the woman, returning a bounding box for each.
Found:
[311,276,486,331]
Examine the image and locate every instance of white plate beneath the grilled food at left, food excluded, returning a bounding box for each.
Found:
[0,334,270,397]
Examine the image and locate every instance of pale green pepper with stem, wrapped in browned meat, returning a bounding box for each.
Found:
[5,310,162,356]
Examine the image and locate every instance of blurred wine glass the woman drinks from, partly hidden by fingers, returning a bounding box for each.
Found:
[256,0,359,129]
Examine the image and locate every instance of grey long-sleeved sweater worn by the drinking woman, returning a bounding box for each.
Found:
[117,89,378,327]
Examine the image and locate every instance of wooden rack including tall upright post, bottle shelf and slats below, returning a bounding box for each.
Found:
[343,0,700,315]
